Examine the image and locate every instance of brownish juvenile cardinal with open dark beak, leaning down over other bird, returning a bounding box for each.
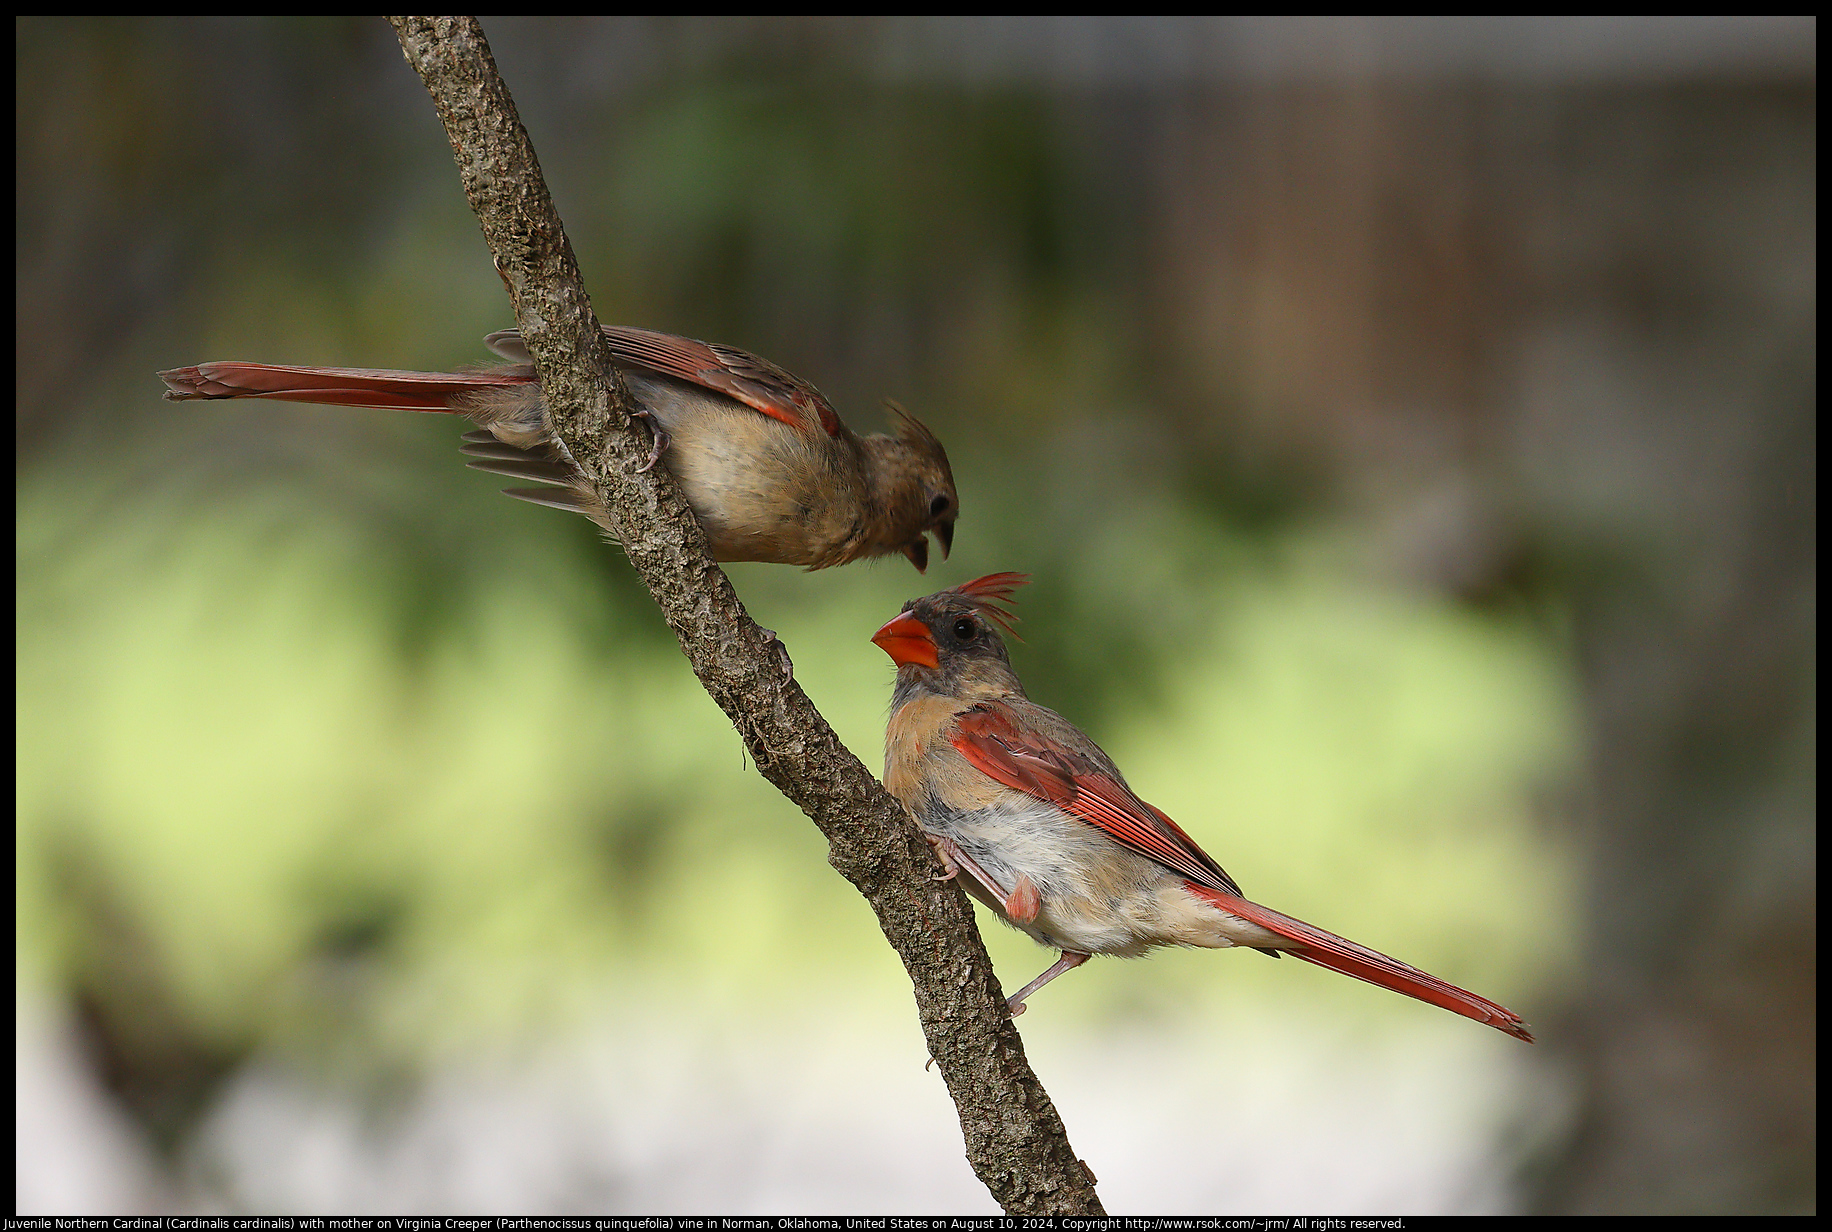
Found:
[159,326,960,572]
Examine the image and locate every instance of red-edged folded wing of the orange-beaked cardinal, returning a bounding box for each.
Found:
[953,706,1240,895]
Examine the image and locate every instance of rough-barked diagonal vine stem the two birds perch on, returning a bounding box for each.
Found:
[388,17,1101,1216]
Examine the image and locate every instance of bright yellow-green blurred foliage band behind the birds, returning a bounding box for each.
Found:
[18,456,1572,1062]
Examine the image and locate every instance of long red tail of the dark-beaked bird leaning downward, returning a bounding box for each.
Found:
[159,359,535,411]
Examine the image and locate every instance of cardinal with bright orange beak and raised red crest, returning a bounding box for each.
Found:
[872,574,1533,1043]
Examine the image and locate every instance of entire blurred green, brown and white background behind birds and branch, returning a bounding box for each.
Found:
[15,17,1817,1214]
